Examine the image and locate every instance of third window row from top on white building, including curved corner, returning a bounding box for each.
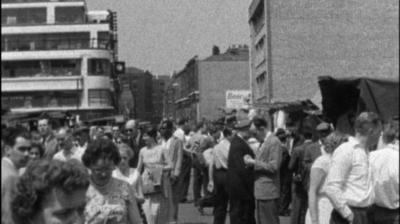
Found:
[1,58,111,78]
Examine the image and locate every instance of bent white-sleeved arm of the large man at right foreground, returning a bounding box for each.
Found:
[325,147,354,219]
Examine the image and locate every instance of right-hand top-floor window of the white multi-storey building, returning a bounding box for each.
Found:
[55,6,85,23]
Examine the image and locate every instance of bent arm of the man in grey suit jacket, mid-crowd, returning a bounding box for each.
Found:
[254,142,282,174]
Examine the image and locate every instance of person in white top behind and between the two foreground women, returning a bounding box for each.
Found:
[53,128,83,161]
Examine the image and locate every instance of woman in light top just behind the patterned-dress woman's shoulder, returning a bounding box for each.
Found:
[112,143,147,224]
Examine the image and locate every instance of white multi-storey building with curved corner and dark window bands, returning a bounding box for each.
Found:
[1,0,116,118]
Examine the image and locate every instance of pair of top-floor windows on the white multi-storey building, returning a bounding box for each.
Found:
[1,6,86,26]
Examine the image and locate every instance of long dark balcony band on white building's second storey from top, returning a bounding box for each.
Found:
[1,38,112,52]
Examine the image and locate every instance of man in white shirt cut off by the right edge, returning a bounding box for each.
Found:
[369,121,399,224]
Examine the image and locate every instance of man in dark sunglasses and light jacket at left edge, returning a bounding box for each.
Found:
[1,128,31,224]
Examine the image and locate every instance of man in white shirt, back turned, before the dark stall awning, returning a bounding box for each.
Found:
[325,112,382,224]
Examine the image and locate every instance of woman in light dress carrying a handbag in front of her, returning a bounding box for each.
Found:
[137,128,172,224]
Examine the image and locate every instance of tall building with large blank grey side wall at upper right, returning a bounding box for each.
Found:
[249,0,399,103]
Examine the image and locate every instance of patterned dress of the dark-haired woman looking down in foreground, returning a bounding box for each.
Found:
[84,177,136,224]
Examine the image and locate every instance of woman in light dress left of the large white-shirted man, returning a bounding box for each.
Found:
[306,132,347,224]
